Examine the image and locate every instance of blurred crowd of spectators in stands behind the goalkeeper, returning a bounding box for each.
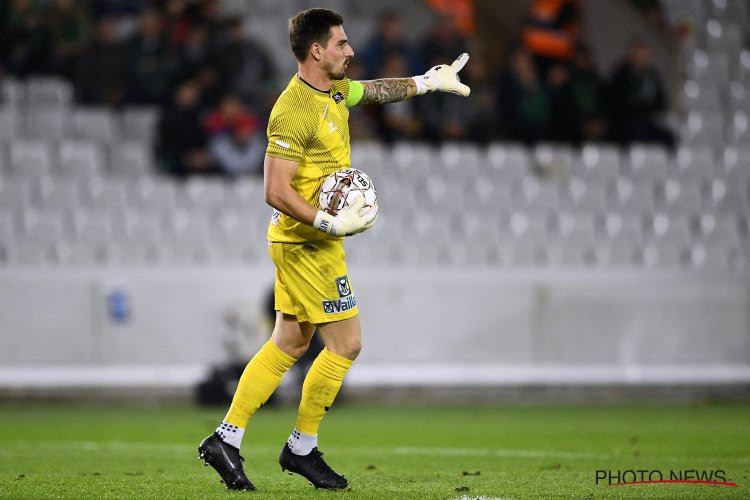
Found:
[0,0,674,179]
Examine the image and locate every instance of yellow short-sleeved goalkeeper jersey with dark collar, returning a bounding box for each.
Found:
[266,75,362,243]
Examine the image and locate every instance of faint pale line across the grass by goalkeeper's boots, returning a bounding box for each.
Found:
[6,441,750,464]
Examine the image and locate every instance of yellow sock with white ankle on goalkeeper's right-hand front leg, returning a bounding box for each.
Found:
[288,349,352,455]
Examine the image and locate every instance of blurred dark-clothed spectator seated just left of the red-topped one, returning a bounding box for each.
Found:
[158,80,216,175]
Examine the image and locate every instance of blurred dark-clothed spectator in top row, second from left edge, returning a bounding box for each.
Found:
[45,0,91,80]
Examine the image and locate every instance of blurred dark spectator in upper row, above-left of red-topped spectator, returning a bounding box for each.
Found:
[126,8,178,104]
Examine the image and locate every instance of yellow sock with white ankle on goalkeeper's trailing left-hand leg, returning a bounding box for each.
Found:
[216,340,296,448]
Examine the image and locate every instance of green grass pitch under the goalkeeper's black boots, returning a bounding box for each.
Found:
[0,402,750,500]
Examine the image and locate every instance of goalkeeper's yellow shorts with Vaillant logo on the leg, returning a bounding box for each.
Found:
[268,240,359,324]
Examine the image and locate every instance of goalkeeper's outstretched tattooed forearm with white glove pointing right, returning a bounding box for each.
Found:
[358,53,471,104]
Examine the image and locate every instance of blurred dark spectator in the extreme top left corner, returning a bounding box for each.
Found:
[0,0,47,77]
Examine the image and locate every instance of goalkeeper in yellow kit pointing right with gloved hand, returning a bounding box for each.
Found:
[198,9,469,490]
